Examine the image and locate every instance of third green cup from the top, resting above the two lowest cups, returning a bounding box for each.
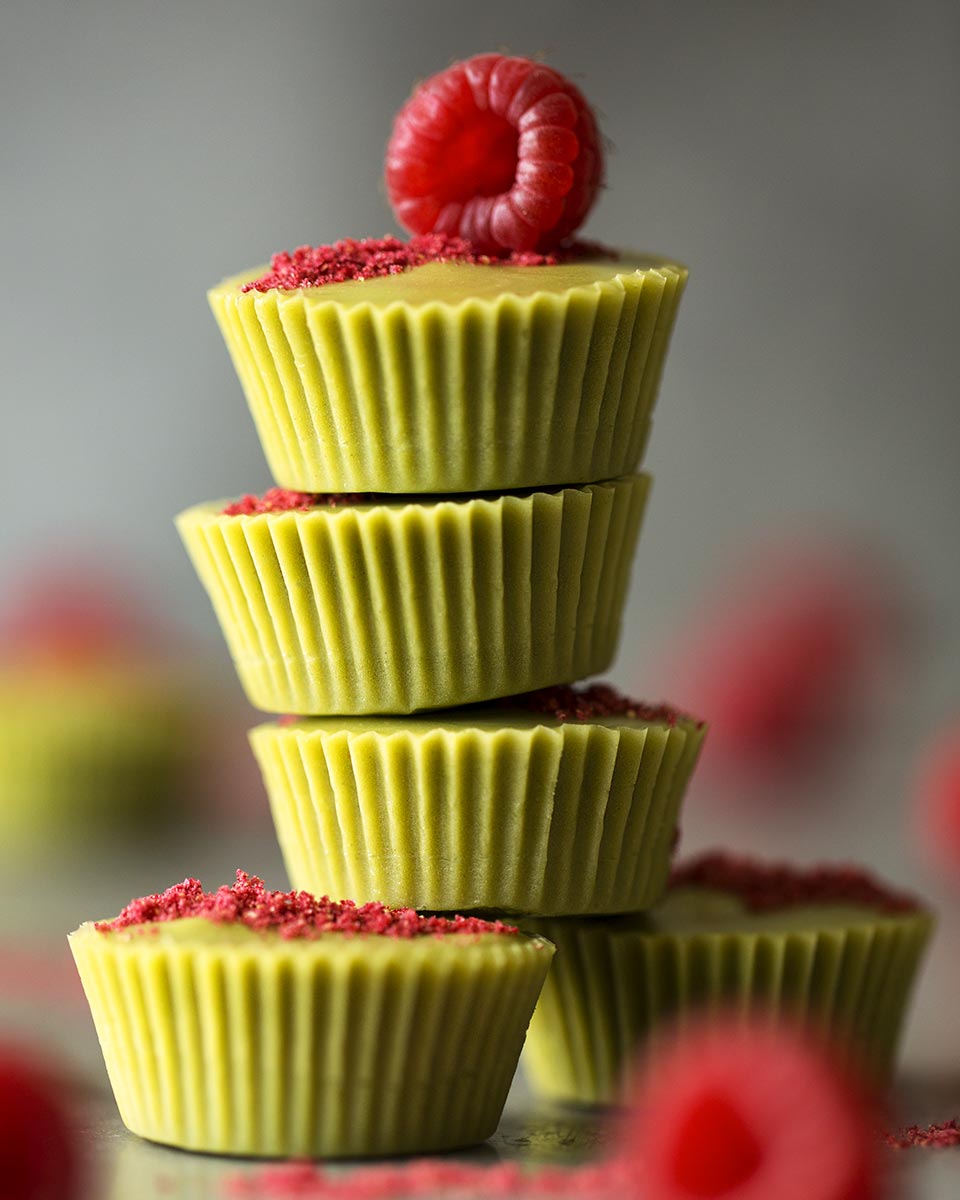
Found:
[251,697,704,914]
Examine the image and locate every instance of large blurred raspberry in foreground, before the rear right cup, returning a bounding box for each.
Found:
[624,1022,881,1200]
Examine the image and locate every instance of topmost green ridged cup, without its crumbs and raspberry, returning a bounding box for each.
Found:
[210,256,686,493]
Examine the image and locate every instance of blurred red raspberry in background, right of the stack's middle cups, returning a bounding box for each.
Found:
[662,535,913,793]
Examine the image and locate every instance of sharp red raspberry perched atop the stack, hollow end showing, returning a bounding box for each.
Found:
[386,54,604,254]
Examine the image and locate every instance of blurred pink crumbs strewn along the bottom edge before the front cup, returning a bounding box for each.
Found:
[220,1158,640,1200]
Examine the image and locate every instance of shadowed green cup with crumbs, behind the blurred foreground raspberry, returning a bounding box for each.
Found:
[523,856,932,1104]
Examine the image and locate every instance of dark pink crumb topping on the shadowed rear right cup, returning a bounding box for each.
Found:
[671,851,922,913]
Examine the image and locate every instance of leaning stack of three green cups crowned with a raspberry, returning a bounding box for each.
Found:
[179,55,702,913]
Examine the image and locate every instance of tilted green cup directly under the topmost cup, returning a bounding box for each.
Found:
[178,475,649,715]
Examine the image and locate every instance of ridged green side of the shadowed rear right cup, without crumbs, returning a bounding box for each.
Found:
[523,912,932,1104]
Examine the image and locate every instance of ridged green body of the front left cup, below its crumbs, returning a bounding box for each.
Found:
[71,926,552,1158]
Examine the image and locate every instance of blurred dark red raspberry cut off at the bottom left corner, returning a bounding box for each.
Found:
[0,1046,80,1200]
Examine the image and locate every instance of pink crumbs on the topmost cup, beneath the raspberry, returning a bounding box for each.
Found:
[240,233,612,292]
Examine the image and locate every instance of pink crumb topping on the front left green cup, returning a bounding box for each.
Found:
[96,871,517,938]
